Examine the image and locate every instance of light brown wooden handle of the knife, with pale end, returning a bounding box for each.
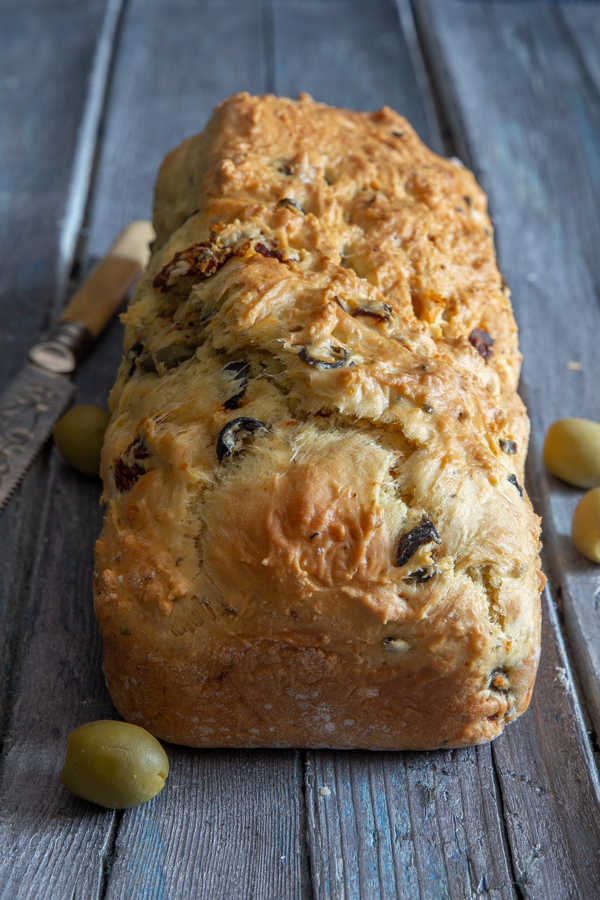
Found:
[59,221,154,339]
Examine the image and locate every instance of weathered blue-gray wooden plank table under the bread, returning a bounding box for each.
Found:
[0,0,600,900]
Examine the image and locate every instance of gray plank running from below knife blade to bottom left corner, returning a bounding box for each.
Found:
[0,450,120,900]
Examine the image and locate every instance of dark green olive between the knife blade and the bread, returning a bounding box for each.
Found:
[54,404,110,478]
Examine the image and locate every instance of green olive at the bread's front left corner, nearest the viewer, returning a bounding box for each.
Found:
[60,719,169,809]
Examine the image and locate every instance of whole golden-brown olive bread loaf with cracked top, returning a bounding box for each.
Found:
[95,94,543,750]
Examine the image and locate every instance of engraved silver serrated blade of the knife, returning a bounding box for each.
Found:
[0,363,76,509]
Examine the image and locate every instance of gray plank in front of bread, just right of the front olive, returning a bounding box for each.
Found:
[106,746,302,900]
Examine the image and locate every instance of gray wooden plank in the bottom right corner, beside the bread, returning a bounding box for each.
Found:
[493,576,600,900]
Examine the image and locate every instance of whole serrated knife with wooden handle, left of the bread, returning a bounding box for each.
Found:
[0,221,154,510]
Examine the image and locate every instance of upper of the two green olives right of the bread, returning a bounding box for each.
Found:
[544,419,600,488]
